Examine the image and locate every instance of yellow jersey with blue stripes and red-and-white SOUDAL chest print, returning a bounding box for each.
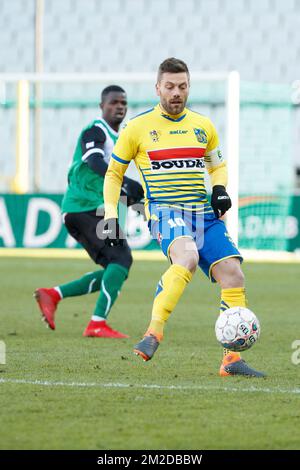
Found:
[108,104,227,218]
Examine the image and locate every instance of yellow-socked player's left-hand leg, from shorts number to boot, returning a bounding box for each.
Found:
[134,209,199,361]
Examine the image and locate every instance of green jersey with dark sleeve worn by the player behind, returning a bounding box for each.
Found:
[62,118,118,213]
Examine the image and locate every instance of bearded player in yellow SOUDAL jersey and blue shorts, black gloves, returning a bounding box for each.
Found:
[103,58,264,377]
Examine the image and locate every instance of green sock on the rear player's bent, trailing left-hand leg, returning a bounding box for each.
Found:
[58,269,105,298]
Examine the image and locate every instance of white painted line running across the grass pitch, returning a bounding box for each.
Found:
[0,378,300,395]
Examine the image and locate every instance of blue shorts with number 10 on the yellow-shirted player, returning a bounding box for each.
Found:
[149,204,243,282]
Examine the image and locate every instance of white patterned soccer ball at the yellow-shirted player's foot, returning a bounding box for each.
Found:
[215,307,260,351]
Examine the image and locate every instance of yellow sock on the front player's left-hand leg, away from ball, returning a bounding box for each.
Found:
[146,264,192,341]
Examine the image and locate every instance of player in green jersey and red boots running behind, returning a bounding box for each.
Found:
[34,85,143,338]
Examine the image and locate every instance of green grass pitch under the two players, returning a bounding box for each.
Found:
[0,258,300,449]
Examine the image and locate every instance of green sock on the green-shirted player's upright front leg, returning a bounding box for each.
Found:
[93,263,128,319]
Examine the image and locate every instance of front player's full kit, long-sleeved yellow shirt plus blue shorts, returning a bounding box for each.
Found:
[104,105,241,281]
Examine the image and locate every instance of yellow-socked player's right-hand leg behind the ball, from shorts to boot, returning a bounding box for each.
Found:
[199,220,264,377]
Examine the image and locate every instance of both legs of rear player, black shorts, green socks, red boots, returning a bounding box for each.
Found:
[35,211,132,337]
